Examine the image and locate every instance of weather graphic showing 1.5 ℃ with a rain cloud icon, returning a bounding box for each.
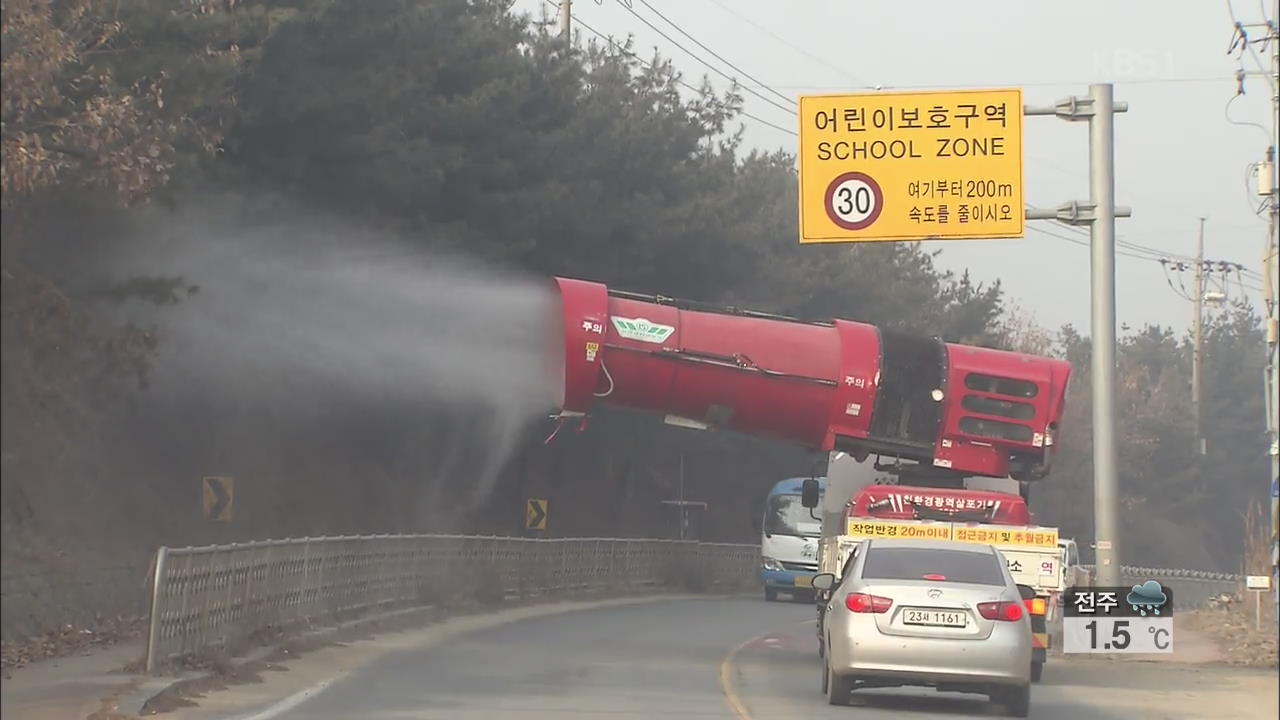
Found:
[1062,580,1174,655]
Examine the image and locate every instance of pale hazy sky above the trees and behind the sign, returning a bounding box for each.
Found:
[515,0,1275,332]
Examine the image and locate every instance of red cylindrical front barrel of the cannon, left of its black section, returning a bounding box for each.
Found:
[556,278,877,448]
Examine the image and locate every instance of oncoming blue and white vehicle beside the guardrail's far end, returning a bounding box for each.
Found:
[759,478,826,602]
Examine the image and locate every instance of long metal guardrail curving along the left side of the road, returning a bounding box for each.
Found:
[146,536,760,673]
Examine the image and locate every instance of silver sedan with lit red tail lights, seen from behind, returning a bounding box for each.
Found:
[813,539,1034,717]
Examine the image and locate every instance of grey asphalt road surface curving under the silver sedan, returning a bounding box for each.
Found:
[225,598,1276,720]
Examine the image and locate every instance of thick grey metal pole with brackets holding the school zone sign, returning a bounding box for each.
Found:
[1023,83,1130,587]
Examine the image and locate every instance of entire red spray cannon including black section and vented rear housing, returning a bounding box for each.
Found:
[553,278,1071,480]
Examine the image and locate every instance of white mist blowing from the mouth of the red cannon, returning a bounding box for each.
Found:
[102,198,558,517]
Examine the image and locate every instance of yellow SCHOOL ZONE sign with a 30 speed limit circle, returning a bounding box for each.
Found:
[800,90,1025,245]
